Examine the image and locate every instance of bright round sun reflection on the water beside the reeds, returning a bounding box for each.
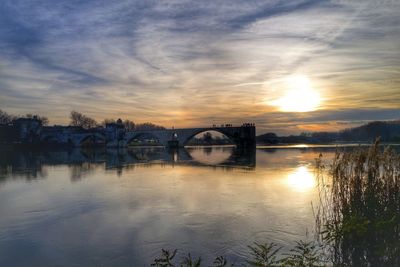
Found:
[287,166,315,192]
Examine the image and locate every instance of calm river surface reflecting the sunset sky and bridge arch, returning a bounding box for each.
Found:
[0,147,350,267]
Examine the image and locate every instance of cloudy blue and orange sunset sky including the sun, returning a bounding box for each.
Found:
[0,0,400,134]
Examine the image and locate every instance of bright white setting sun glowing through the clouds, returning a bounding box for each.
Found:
[272,75,321,112]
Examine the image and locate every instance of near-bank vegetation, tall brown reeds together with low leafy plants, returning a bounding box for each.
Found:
[151,140,400,267]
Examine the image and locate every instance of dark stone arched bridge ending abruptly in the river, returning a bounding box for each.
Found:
[40,124,256,147]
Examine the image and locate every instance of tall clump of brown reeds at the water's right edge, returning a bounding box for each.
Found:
[317,141,400,266]
